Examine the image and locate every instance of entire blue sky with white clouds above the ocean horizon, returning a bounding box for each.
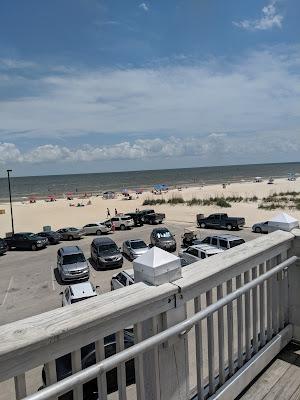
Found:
[0,0,300,175]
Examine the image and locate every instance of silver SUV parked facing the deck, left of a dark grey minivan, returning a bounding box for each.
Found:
[57,246,90,282]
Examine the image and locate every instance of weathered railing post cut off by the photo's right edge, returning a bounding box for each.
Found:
[288,229,300,341]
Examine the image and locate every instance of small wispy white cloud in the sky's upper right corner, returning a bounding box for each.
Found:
[233,0,283,31]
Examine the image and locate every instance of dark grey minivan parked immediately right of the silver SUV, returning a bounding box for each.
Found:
[91,237,123,269]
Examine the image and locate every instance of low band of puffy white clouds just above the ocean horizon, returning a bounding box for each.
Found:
[0,129,300,165]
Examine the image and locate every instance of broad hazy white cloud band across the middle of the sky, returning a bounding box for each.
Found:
[0,47,300,151]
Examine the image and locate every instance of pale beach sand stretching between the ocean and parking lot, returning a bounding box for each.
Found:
[0,179,300,237]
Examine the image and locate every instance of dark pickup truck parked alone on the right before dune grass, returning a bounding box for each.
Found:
[197,214,245,231]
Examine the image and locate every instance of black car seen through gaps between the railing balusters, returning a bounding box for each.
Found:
[42,330,135,400]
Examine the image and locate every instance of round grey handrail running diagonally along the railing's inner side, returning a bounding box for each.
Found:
[21,256,298,400]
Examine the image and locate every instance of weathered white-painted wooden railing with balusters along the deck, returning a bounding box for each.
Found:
[0,231,300,400]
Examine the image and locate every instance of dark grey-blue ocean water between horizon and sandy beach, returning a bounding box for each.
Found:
[0,163,300,201]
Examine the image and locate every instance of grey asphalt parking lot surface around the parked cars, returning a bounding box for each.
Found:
[0,222,259,324]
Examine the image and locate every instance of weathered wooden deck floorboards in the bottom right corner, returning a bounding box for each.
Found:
[239,343,300,400]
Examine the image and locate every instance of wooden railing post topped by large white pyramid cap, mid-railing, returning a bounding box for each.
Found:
[133,247,188,400]
